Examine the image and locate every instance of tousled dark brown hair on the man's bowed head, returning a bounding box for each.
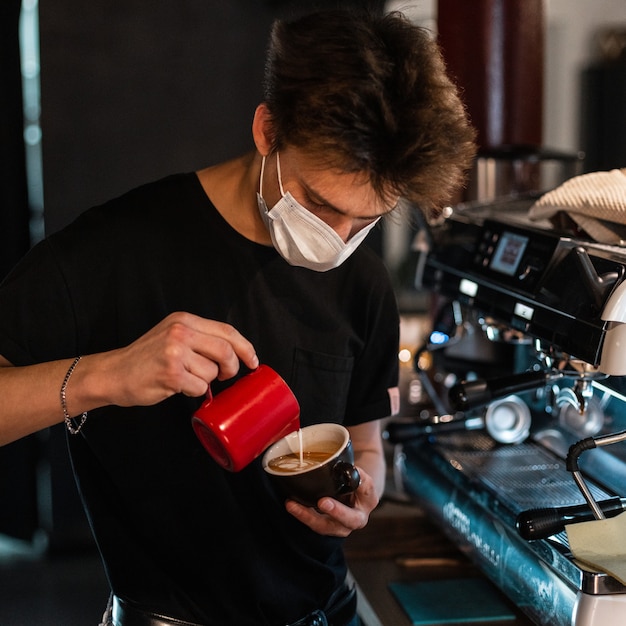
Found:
[264,10,475,209]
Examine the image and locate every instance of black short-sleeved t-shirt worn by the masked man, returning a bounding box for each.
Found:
[0,174,398,626]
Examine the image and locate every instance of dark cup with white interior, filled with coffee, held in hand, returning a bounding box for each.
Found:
[263,424,361,507]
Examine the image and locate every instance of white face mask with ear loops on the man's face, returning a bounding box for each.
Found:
[257,153,380,272]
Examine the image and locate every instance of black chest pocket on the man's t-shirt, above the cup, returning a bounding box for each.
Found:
[291,348,354,426]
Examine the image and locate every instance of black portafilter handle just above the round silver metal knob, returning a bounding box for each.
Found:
[448,370,560,411]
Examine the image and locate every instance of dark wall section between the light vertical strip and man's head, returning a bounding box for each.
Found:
[40,0,289,233]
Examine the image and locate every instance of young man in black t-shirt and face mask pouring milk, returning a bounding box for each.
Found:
[0,12,474,626]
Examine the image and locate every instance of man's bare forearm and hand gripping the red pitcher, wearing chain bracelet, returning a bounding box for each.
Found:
[0,313,258,445]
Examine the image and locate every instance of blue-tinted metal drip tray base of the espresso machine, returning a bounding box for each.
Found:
[401,432,626,626]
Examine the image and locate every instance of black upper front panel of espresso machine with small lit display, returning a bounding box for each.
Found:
[416,202,626,365]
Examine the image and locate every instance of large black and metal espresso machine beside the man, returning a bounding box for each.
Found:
[385,194,626,626]
